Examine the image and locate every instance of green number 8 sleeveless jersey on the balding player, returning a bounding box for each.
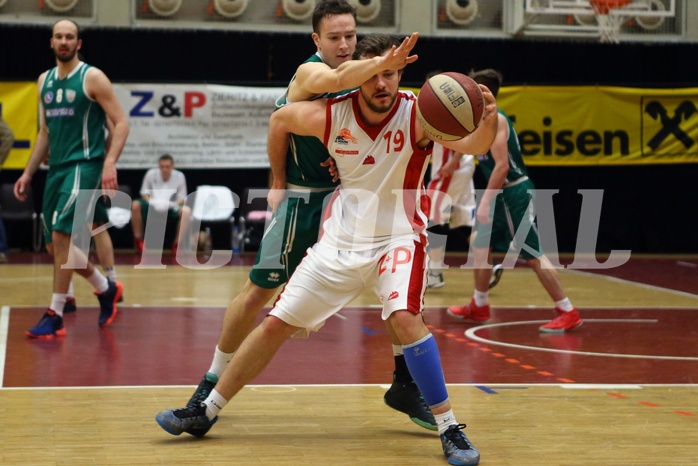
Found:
[41,62,106,167]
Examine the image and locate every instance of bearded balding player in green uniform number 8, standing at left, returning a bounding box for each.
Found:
[15,20,129,338]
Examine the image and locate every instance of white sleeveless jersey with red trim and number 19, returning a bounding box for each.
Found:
[321,91,431,251]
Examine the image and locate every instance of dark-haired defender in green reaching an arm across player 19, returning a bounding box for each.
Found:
[179,0,437,430]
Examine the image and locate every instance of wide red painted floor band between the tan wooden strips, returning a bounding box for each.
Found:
[4,307,698,387]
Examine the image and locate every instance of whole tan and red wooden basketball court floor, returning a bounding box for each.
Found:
[0,254,698,465]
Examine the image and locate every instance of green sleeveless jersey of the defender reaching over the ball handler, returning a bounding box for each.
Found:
[276,53,351,188]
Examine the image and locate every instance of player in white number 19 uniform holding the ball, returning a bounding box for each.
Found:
[156,35,497,465]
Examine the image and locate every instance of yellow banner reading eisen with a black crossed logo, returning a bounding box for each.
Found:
[498,86,698,166]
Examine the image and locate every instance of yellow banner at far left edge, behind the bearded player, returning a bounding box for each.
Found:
[0,82,39,169]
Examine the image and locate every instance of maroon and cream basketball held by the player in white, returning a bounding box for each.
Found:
[417,72,485,141]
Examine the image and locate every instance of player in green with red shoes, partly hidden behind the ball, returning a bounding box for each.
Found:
[447,69,582,333]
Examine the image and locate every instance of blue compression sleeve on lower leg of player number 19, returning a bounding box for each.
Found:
[402,334,448,406]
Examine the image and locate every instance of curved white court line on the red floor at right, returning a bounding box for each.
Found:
[464,319,698,361]
